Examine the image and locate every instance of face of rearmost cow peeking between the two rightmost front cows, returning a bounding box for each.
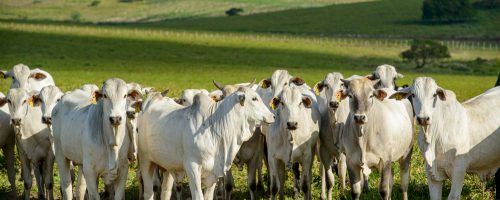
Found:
[367,65,404,89]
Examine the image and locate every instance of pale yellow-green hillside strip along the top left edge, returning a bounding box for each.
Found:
[0,0,366,22]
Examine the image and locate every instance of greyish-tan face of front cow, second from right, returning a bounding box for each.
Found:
[342,78,387,125]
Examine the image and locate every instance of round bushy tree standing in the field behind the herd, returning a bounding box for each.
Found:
[400,40,451,69]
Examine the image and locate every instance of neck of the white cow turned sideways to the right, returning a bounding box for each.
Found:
[207,95,251,177]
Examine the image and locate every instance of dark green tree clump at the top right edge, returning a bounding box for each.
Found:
[422,0,475,23]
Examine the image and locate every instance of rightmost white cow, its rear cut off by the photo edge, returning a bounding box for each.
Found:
[390,77,500,199]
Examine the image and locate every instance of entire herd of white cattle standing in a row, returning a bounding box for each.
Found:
[0,64,500,199]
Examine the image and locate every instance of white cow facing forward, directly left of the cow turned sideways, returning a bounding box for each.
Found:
[52,79,135,199]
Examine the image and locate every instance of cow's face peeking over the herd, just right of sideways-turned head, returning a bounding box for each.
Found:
[261,70,305,101]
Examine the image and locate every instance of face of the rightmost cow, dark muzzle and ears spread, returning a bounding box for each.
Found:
[390,77,446,126]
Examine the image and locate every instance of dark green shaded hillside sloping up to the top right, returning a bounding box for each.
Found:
[139,0,500,41]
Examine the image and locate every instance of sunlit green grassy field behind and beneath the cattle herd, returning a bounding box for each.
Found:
[0,19,500,199]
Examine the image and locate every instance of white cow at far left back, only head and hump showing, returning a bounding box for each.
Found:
[0,64,55,91]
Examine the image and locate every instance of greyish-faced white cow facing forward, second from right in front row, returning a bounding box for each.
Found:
[341,78,413,199]
